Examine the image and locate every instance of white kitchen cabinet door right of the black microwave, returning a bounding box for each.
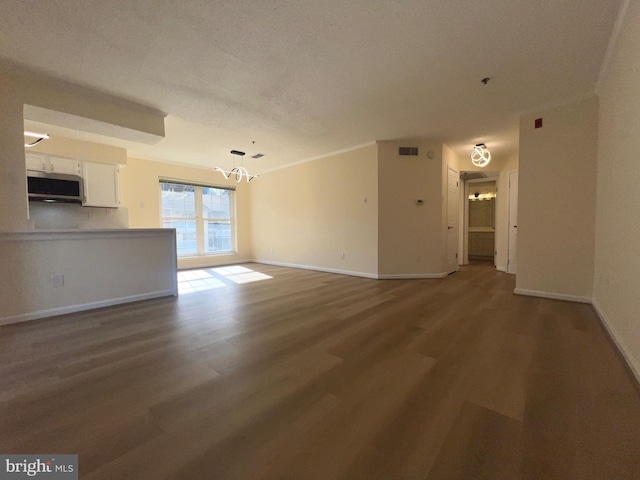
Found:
[82,162,120,208]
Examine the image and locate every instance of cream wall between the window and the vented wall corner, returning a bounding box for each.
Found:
[249,145,378,276]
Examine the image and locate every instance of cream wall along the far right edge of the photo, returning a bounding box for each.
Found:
[593,1,640,379]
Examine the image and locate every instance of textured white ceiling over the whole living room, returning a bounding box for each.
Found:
[0,0,621,172]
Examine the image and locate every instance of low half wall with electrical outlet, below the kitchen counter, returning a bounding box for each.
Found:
[0,230,177,324]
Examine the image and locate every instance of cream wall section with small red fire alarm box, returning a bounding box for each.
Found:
[516,96,598,302]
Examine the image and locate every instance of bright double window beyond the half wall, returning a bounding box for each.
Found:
[160,181,235,256]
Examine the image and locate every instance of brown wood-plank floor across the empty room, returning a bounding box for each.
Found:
[0,264,640,480]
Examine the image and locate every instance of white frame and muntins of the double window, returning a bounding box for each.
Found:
[158,178,238,258]
